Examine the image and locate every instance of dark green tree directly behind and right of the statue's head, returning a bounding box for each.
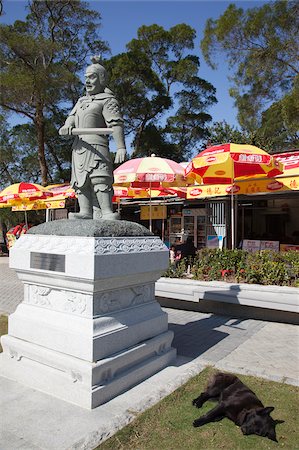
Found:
[107,24,216,160]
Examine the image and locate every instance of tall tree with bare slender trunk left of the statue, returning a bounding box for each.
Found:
[0,0,108,185]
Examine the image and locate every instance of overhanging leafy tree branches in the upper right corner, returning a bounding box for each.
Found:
[201,1,299,135]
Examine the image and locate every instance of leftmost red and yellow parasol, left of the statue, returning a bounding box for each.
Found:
[0,182,53,206]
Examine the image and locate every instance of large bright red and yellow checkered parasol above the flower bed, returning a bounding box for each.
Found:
[186,144,283,184]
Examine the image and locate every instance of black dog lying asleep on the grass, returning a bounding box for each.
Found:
[192,372,284,442]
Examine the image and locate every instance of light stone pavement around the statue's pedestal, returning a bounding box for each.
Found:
[0,257,299,450]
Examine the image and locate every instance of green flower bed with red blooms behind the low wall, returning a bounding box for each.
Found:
[163,249,299,287]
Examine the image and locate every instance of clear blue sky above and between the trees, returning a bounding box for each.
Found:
[1,0,264,135]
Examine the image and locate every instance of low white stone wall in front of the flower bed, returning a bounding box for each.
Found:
[155,277,299,323]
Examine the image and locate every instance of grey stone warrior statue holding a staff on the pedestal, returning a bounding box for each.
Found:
[59,57,126,220]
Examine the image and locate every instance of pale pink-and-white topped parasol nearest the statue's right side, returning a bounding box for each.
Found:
[114,155,187,189]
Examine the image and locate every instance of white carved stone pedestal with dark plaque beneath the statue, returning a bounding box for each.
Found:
[0,221,176,408]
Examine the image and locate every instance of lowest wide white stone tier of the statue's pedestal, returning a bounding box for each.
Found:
[1,331,176,409]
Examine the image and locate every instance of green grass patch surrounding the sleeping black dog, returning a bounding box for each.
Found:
[97,368,299,450]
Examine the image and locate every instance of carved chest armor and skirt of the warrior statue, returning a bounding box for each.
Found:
[70,89,123,191]
